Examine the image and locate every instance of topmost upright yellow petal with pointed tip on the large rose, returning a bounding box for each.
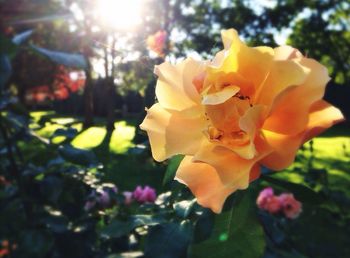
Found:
[209,29,274,88]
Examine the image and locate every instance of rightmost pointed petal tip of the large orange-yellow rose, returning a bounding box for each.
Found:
[303,100,344,142]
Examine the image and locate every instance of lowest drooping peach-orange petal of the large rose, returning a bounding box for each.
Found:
[175,156,249,213]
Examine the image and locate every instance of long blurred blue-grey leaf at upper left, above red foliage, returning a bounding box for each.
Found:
[31,45,87,69]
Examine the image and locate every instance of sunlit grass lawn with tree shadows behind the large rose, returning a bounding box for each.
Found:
[31,111,350,195]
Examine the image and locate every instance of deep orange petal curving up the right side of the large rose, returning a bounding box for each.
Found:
[263,58,329,134]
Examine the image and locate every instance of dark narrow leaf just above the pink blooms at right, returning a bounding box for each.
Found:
[261,175,323,204]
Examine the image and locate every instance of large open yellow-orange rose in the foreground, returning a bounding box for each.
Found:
[141,29,343,213]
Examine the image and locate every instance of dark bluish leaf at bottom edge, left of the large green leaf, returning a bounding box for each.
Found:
[145,220,193,258]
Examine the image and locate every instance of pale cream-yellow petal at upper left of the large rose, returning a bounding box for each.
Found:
[155,58,205,111]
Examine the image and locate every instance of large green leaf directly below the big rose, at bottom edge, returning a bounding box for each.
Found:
[191,191,265,258]
